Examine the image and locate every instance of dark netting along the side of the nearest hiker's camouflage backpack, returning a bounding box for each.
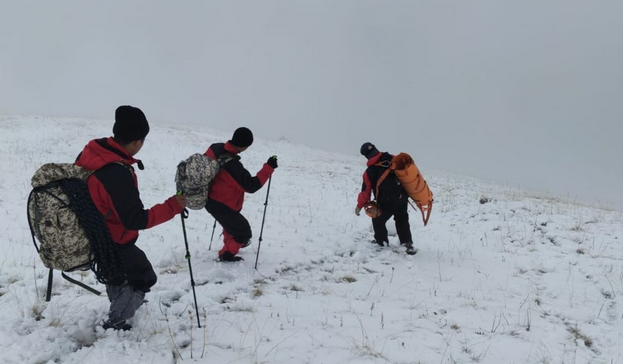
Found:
[60,179,125,284]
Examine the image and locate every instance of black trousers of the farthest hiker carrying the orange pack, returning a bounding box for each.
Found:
[372,196,413,244]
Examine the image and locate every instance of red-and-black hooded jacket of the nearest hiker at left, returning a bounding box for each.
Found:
[76,138,183,244]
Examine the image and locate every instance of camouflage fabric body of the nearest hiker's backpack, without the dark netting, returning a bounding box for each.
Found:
[28,163,94,272]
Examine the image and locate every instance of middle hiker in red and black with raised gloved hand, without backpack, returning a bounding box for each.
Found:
[205,127,277,262]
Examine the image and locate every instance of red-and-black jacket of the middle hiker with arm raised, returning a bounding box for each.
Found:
[205,142,274,211]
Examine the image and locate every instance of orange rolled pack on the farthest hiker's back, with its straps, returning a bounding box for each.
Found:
[376,153,433,226]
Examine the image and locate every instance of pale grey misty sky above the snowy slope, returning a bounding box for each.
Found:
[0,0,623,210]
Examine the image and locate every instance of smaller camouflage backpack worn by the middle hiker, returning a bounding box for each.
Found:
[175,153,236,210]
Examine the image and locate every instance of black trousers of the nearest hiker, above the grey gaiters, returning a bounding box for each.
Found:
[118,244,158,292]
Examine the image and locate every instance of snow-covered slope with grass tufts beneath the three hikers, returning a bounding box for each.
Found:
[0,116,623,364]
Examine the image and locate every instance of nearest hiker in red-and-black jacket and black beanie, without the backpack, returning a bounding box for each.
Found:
[76,106,186,330]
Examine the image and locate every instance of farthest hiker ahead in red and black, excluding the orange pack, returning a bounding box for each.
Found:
[355,143,413,250]
